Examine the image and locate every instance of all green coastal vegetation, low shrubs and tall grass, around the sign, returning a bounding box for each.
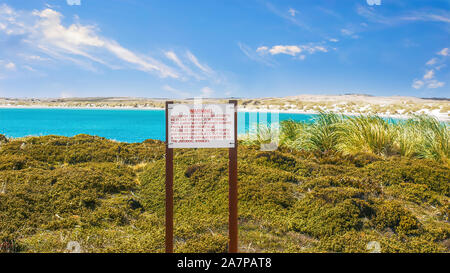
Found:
[0,114,450,252]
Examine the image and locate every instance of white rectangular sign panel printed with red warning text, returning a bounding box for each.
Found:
[167,104,236,148]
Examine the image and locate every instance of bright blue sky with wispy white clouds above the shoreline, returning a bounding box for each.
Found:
[0,0,450,98]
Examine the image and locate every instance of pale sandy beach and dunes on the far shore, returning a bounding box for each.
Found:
[0,95,450,122]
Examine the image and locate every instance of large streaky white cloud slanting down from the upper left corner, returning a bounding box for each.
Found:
[0,4,179,78]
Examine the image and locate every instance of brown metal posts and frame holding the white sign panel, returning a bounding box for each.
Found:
[165,100,238,253]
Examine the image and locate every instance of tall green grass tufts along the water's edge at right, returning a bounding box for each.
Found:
[242,112,450,165]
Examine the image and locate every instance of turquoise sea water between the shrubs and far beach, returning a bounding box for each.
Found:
[0,108,314,143]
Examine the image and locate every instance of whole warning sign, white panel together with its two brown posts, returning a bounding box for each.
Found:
[166,100,238,253]
